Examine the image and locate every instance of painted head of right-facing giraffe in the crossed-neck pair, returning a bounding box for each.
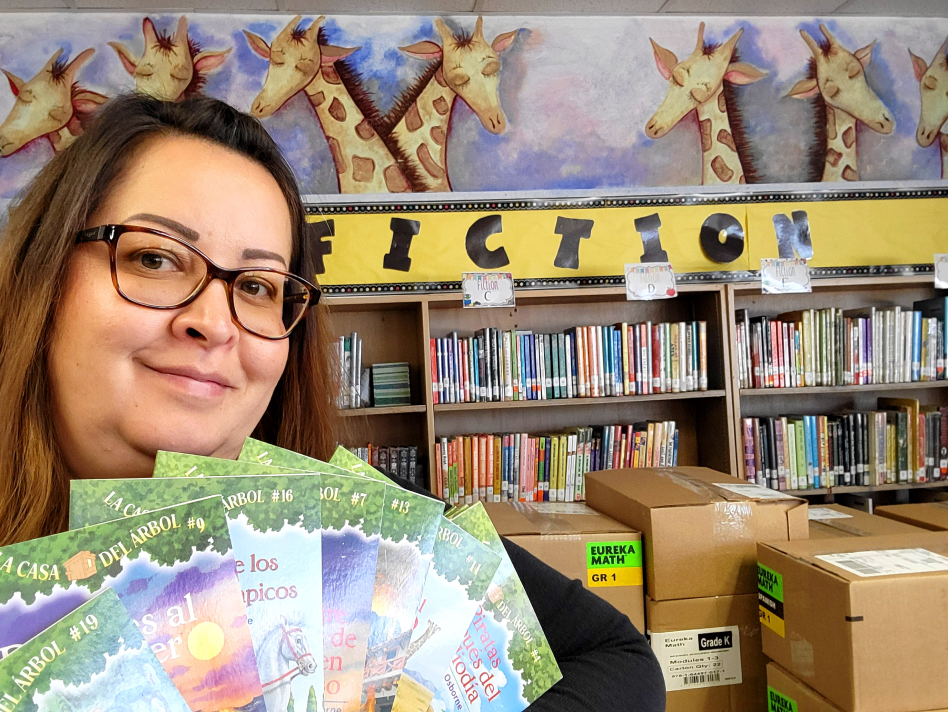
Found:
[401,17,520,134]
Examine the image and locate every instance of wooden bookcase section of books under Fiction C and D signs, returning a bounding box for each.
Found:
[326,285,738,501]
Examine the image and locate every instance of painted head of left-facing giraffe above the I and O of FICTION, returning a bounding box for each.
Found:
[645,22,767,139]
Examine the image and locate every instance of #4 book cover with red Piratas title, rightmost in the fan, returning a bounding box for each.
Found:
[448,503,563,712]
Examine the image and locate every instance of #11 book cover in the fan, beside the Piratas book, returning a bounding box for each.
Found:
[393,517,500,710]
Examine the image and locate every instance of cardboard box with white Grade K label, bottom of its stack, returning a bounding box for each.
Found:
[646,594,767,712]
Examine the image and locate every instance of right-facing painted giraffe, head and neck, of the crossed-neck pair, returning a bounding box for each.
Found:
[378,17,519,192]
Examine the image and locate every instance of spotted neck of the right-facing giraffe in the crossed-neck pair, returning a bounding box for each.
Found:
[392,67,457,192]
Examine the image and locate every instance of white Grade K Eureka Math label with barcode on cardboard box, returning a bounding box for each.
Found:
[649,625,743,692]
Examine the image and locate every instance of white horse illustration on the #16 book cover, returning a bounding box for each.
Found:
[256,615,317,712]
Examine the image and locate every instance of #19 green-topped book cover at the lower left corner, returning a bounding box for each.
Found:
[0,589,190,712]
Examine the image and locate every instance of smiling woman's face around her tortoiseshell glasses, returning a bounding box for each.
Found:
[48,137,292,478]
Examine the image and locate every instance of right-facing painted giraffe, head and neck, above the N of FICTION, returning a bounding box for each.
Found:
[787,25,895,182]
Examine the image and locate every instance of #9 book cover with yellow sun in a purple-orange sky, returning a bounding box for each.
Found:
[0,496,264,712]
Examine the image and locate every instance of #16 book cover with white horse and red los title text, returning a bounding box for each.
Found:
[69,474,323,712]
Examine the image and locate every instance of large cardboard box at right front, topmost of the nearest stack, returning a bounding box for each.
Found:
[758,532,948,712]
